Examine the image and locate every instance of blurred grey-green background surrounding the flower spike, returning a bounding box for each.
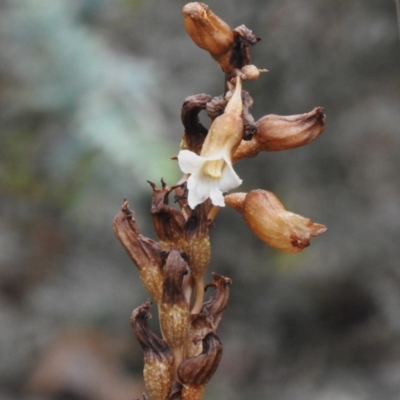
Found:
[0,0,400,400]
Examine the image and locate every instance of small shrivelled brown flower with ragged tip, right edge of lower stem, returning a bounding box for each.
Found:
[201,272,232,330]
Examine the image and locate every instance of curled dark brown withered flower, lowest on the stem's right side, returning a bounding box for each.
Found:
[178,330,222,386]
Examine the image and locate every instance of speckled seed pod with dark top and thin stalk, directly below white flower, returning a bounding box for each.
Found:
[185,202,211,314]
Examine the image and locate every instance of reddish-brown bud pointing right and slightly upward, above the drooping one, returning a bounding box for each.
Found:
[233,107,325,161]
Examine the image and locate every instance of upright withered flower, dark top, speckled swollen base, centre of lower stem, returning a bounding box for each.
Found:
[160,248,190,366]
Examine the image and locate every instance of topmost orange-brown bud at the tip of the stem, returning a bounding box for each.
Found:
[182,2,233,65]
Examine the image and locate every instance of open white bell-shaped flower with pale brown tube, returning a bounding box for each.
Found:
[178,77,244,208]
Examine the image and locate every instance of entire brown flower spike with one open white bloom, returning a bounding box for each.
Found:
[113,2,326,400]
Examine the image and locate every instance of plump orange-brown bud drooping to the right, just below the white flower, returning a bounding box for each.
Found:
[225,190,327,253]
